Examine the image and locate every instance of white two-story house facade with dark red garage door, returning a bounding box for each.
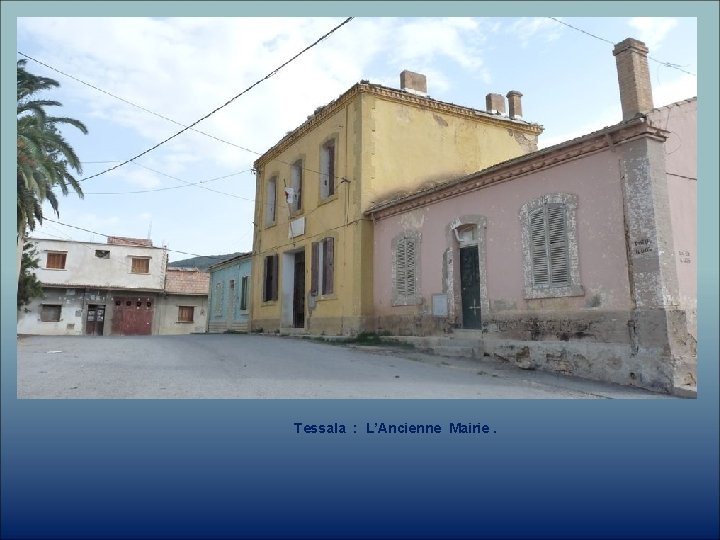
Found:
[17,237,167,335]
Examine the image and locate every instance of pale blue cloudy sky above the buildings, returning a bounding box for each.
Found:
[11,13,698,261]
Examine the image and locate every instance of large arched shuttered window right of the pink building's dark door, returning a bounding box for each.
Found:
[520,193,584,298]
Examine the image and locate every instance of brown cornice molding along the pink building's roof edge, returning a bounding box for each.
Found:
[365,117,669,220]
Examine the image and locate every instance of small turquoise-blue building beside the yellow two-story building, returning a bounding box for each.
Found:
[207,253,252,334]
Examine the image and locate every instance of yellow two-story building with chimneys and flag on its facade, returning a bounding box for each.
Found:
[251,71,542,335]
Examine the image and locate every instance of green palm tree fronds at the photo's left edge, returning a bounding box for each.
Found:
[17,60,87,234]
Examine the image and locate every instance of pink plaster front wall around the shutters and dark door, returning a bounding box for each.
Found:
[374,150,631,320]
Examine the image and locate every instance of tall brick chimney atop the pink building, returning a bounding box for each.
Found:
[613,38,653,120]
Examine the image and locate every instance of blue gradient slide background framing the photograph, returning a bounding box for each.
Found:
[0,2,719,538]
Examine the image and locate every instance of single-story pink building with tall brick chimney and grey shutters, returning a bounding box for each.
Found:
[367,39,697,393]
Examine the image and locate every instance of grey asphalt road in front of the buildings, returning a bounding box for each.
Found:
[17,334,673,399]
